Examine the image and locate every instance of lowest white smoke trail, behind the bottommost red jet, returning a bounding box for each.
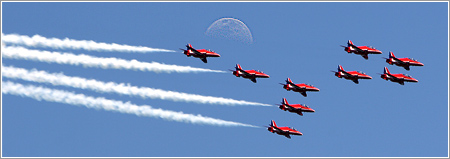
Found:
[2,81,257,127]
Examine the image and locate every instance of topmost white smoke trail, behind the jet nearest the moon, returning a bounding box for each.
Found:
[2,33,175,53]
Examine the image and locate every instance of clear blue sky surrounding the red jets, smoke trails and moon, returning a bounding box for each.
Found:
[2,2,448,157]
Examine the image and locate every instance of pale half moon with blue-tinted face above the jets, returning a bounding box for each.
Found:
[205,18,253,44]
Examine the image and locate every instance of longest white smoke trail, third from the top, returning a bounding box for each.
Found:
[1,65,271,106]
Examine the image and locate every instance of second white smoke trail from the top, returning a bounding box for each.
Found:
[2,46,225,73]
